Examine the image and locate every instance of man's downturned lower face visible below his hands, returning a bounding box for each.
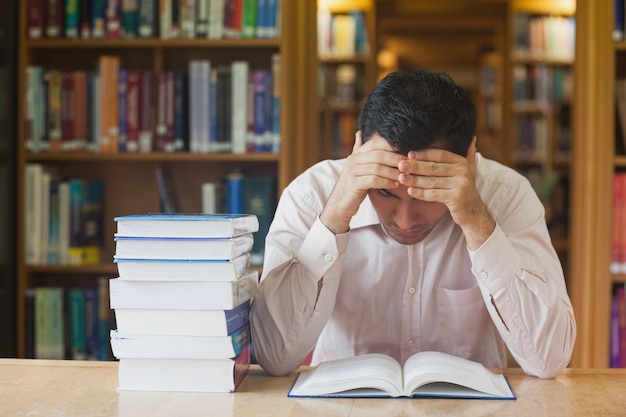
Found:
[368,185,448,245]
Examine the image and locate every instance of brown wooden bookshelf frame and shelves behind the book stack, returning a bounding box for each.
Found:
[16,1,317,357]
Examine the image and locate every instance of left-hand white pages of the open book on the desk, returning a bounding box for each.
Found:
[290,353,402,396]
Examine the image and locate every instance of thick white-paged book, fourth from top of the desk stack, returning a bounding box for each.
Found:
[109,270,259,310]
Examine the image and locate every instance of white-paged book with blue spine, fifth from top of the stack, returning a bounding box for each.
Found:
[115,300,250,337]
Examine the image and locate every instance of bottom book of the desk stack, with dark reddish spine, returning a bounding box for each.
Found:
[118,346,250,392]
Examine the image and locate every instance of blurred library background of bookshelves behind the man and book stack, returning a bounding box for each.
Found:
[0,0,626,367]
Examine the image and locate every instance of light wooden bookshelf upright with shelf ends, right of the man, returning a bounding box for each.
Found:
[569,0,626,368]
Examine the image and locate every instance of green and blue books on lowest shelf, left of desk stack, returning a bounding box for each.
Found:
[25,277,113,360]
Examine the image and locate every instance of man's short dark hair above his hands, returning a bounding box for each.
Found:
[359,69,476,156]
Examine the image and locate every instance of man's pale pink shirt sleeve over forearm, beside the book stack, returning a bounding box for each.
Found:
[250,179,348,375]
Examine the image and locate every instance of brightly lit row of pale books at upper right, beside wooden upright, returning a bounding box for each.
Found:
[514,13,576,60]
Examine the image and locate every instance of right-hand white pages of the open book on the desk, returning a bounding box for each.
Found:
[404,352,514,398]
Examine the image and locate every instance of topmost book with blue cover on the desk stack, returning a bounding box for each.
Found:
[114,213,259,238]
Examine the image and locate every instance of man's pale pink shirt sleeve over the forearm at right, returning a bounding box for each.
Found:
[469,176,576,378]
